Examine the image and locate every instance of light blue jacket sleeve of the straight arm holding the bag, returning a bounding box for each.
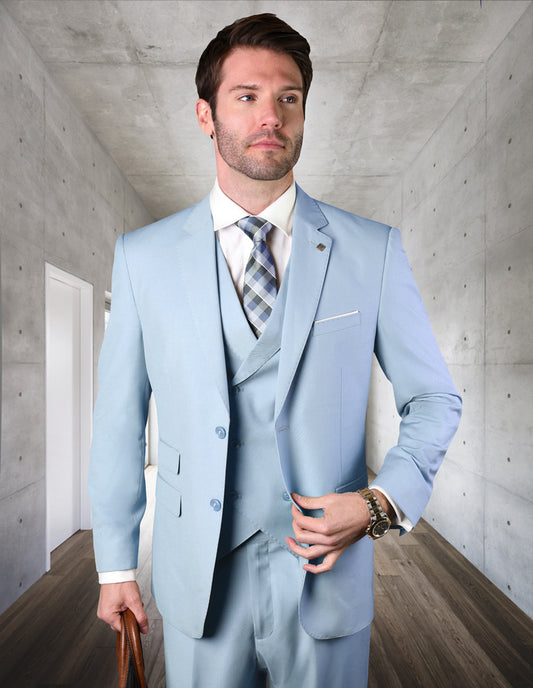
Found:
[89,235,151,571]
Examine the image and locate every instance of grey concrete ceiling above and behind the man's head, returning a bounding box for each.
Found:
[2,0,530,219]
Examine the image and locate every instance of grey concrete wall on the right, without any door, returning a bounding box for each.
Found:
[368,7,533,615]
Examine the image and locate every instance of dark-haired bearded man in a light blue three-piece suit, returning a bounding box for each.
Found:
[90,14,460,688]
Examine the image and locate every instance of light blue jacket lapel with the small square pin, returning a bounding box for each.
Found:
[275,187,332,418]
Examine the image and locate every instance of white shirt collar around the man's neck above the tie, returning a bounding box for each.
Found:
[209,179,296,236]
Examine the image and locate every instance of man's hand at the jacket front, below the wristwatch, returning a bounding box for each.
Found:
[286,490,390,573]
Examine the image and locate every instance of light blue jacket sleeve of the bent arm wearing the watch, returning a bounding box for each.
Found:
[375,228,461,524]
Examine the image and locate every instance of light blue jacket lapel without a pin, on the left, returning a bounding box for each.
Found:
[177,198,229,412]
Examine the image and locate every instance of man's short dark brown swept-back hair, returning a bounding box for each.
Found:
[196,13,313,117]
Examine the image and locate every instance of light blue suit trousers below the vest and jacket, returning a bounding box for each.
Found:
[163,532,370,688]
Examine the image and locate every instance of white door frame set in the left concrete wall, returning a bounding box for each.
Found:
[45,263,93,571]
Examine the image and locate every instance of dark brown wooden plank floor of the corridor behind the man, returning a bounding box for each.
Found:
[0,470,533,688]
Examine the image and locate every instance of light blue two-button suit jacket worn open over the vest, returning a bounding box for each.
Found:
[89,188,461,638]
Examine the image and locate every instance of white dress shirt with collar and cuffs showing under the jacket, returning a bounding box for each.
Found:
[98,180,413,583]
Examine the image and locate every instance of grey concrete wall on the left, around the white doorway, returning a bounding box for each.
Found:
[0,6,150,612]
